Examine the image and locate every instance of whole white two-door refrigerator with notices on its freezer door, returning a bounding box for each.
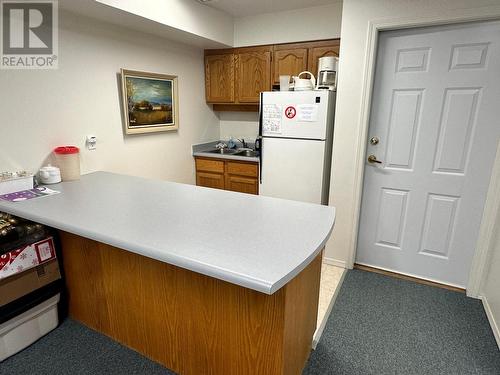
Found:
[258,90,336,205]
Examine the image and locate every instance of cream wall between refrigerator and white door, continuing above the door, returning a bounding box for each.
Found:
[325,0,500,265]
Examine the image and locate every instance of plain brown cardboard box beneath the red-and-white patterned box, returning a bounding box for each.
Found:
[0,259,61,306]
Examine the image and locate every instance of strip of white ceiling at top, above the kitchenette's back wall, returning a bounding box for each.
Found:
[199,0,342,17]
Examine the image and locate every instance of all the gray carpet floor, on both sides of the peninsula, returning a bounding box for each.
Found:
[0,270,500,375]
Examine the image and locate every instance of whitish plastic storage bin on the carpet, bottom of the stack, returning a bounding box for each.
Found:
[0,294,59,362]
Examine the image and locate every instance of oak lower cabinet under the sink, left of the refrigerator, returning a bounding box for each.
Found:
[195,157,259,194]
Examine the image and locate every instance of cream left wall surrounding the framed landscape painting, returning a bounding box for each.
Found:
[0,11,219,187]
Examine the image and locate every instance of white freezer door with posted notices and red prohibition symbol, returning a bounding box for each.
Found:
[260,91,334,140]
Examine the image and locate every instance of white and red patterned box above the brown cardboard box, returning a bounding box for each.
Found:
[0,237,56,281]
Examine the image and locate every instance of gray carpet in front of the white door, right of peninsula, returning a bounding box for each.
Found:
[303,270,500,375]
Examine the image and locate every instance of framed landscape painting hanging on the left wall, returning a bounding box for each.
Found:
[121,69,179,134]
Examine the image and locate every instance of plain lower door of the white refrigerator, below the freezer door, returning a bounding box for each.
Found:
[259,138,325,204]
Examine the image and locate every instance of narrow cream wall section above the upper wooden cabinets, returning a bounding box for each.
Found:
[234,1,342,47]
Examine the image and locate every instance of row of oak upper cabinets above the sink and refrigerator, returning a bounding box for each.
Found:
[205,39,340,111]
